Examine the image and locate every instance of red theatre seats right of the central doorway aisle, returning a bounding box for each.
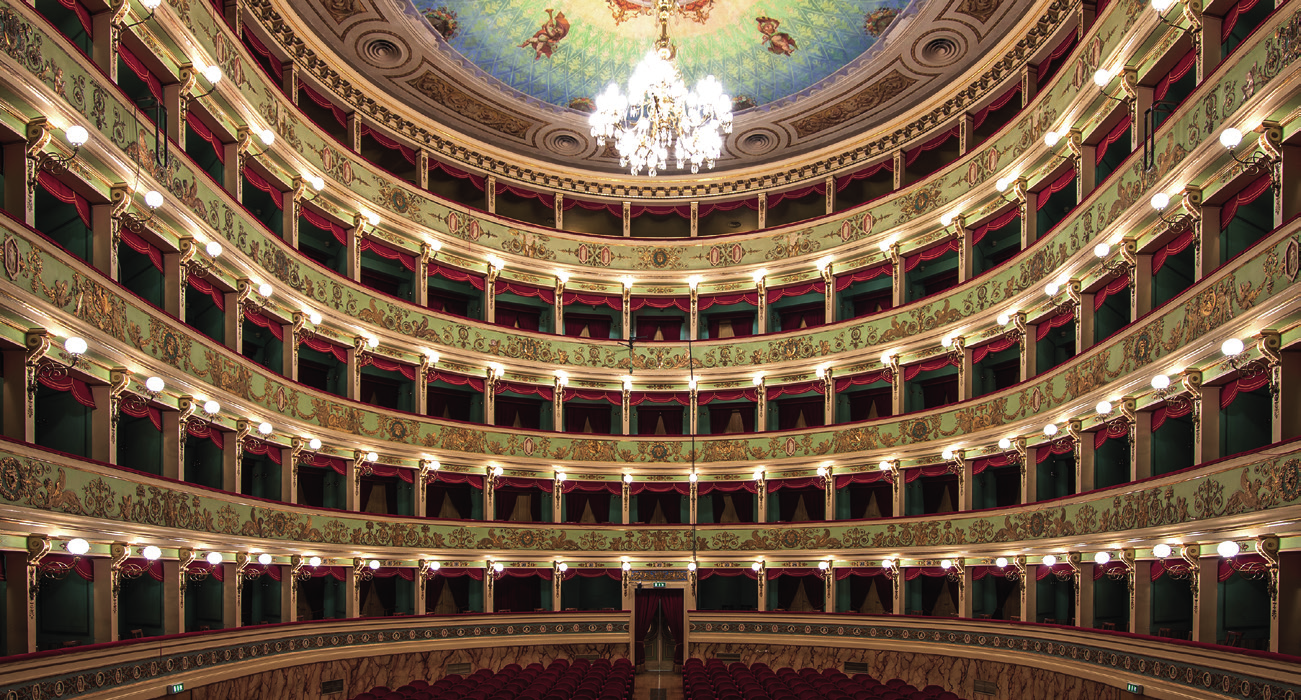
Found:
[682,658,961,700]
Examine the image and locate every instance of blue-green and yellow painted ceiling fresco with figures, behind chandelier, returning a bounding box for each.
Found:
[409,0,922,111]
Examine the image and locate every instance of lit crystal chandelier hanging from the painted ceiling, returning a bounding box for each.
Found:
[588,0,731,177]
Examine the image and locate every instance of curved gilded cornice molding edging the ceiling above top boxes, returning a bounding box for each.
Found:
[246,0,1079,200]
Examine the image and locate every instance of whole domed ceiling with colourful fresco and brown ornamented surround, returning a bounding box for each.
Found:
[287,0,1046,176]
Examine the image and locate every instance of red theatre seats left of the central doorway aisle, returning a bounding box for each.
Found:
[351,658,634,700]
